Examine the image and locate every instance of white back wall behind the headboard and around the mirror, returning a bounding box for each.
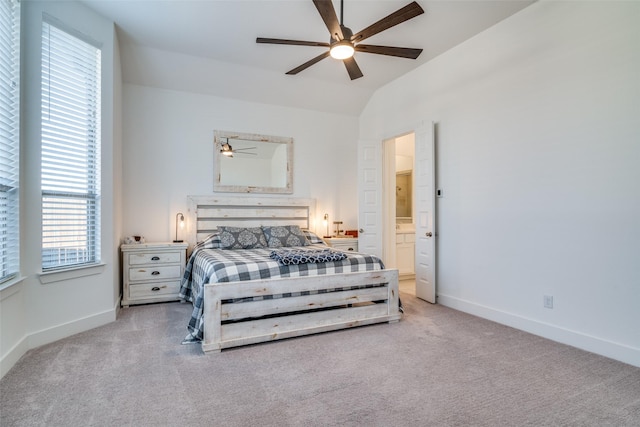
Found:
[121,84,358,241]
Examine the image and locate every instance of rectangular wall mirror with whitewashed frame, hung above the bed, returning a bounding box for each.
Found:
[213,130,293,194]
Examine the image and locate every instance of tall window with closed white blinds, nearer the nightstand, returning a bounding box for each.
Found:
[41,17,101,271]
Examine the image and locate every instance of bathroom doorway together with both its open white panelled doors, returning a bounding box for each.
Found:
[358,120,437,304]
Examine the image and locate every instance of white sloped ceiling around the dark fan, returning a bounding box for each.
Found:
[81,0,533,115]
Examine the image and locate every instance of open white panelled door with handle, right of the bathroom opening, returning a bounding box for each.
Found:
[414,122,436,304]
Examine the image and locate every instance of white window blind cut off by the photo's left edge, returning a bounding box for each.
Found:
[0,0,20,283]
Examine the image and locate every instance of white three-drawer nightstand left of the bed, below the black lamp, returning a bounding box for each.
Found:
[120,243,188,307]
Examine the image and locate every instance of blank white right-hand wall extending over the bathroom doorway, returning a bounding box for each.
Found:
[360,2,640,366]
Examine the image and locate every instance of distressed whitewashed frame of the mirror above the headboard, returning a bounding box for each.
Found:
[213,130,293,194]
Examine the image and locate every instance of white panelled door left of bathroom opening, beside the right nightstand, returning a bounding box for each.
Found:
[358,140,383,259]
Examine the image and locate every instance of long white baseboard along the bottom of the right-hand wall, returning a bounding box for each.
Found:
[438,294,640,367]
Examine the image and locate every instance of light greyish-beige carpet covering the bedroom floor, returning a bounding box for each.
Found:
[0,293,640,426]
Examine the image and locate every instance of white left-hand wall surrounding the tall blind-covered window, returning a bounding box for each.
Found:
[0,1,121,375]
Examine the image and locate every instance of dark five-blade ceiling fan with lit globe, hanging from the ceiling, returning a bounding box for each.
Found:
[256,0,424,80]
